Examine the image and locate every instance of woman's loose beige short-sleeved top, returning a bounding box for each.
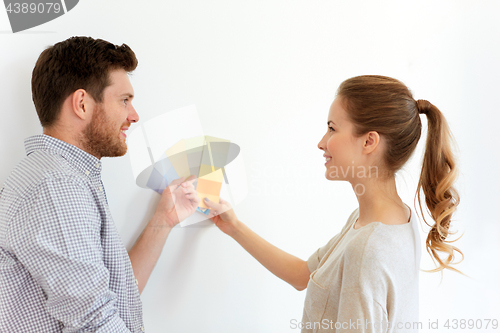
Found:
[300,208,421,333]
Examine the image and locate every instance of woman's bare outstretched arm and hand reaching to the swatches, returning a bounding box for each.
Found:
[205,199,311,290]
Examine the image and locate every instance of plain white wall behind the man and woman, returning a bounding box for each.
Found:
[0,0,500,333]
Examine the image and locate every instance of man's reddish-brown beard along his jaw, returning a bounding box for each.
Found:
[81,104,127,158]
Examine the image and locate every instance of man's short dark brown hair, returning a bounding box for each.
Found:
[31,37,137,127]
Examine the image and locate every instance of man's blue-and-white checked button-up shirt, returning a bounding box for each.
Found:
[0,135,144,333]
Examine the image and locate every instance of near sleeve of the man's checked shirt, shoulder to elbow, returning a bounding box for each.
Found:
[12,178,130,333]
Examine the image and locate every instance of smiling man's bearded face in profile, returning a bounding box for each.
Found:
[83,69,139,158]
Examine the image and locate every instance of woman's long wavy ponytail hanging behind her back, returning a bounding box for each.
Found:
[416,100,464,273]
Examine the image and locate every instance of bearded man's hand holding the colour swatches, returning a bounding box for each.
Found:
[155,175,200,228]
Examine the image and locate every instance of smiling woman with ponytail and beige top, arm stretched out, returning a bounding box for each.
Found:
[201,75,463,332]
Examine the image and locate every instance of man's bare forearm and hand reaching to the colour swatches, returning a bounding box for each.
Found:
[128,176,200,293]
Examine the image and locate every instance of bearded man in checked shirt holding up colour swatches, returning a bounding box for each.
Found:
[0,37,200,333]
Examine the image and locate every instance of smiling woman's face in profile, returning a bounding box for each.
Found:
[318,97,362,181]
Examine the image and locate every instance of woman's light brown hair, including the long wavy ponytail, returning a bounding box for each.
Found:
[337,75,464,273]
